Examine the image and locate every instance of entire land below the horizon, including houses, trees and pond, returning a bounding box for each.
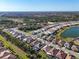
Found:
[0,12,79,59]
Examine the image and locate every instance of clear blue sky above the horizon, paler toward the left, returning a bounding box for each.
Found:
[0,0,79,11]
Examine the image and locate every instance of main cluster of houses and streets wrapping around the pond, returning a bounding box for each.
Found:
[3,21,79,59]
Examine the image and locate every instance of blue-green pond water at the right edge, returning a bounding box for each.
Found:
[61,26,79,38]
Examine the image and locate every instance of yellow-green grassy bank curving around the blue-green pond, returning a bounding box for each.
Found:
[56,25,79,42]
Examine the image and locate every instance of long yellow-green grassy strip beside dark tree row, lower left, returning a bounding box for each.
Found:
[0,35,29,59]
